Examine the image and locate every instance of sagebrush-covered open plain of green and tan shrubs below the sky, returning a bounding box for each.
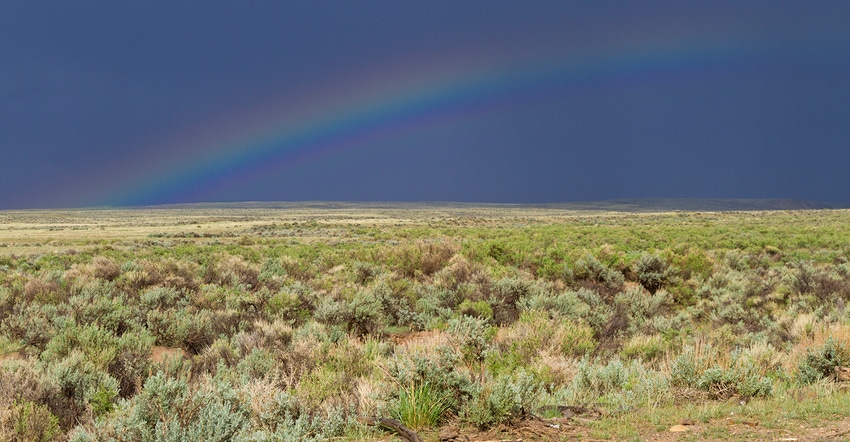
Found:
[0,203,850,441]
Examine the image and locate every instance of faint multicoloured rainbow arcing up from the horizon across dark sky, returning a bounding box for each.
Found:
[86,38,757,206]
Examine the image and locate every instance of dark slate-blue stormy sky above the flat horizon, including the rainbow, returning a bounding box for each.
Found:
[0,0,850,209]
